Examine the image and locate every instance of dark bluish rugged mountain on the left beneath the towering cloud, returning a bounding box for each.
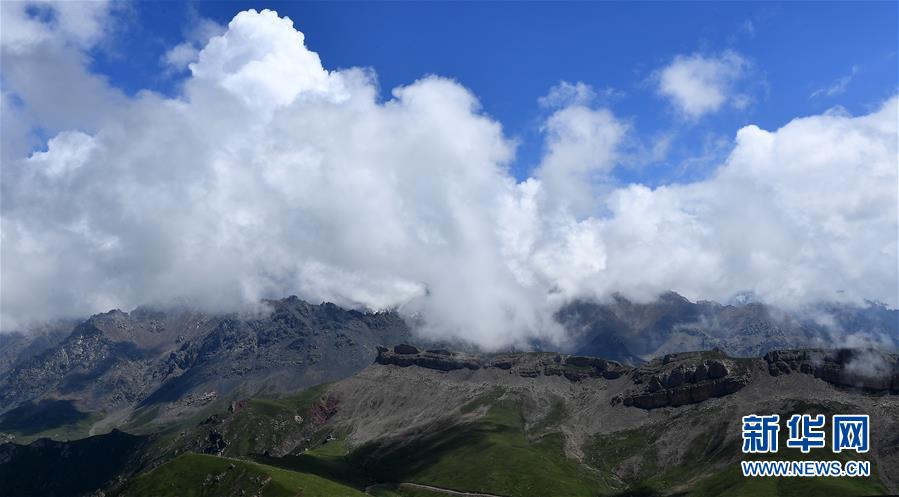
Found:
[0,297,414,419]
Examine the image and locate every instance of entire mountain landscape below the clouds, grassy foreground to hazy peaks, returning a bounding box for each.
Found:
[0,293,899,496]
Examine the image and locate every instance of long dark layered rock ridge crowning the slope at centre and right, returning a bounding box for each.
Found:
[375,344,899,409]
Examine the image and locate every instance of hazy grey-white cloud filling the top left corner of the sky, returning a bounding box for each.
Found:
[0,1,125,146]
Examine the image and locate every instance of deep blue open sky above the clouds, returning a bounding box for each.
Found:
[94,2,899,185]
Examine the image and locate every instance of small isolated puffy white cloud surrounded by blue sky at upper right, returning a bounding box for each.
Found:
[656,50,749,119]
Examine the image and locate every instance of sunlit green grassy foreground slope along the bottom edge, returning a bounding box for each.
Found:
[241,392,885,497]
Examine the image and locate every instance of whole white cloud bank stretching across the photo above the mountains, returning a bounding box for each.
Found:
[0,4,897,348]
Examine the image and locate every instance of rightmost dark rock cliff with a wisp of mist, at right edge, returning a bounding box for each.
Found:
[764,349,899,394]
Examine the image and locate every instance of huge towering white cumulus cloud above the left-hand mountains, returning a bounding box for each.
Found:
[2,11,551,346]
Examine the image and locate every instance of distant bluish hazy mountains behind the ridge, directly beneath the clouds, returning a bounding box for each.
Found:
[0,293,899,444]
